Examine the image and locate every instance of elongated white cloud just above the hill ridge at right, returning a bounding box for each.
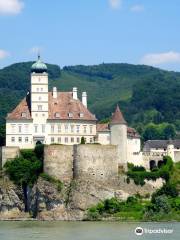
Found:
[141,51,180,65]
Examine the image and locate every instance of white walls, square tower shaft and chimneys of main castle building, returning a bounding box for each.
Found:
[6,58,96,149]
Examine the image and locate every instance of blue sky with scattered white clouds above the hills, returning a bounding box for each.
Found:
[0,0,180,71]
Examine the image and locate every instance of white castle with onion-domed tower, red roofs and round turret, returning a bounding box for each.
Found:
[6,57,142,164]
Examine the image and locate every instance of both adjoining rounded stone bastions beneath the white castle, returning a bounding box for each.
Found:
[44,144,118,181]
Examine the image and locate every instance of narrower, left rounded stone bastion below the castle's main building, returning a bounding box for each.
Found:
[44,145,73,181]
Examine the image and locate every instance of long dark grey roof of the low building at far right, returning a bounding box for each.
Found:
[144,140,180,151]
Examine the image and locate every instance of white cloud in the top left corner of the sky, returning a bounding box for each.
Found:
[0,0,24,15]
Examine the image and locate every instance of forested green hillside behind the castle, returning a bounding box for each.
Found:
[0,62,180,143]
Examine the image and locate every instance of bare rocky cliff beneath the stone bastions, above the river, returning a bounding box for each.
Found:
[0,176,163,220]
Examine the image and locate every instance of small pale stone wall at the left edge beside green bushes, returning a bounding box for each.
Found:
[0,147,20,169]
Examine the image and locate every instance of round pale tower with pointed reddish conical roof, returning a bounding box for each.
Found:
[110,105,127,167]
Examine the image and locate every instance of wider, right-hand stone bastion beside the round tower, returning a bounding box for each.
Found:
[74,144,118,181]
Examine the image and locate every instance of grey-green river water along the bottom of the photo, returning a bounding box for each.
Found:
[0,221,180,240]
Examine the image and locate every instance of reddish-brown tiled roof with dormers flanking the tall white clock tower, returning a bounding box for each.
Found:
[7,92,96,121]
